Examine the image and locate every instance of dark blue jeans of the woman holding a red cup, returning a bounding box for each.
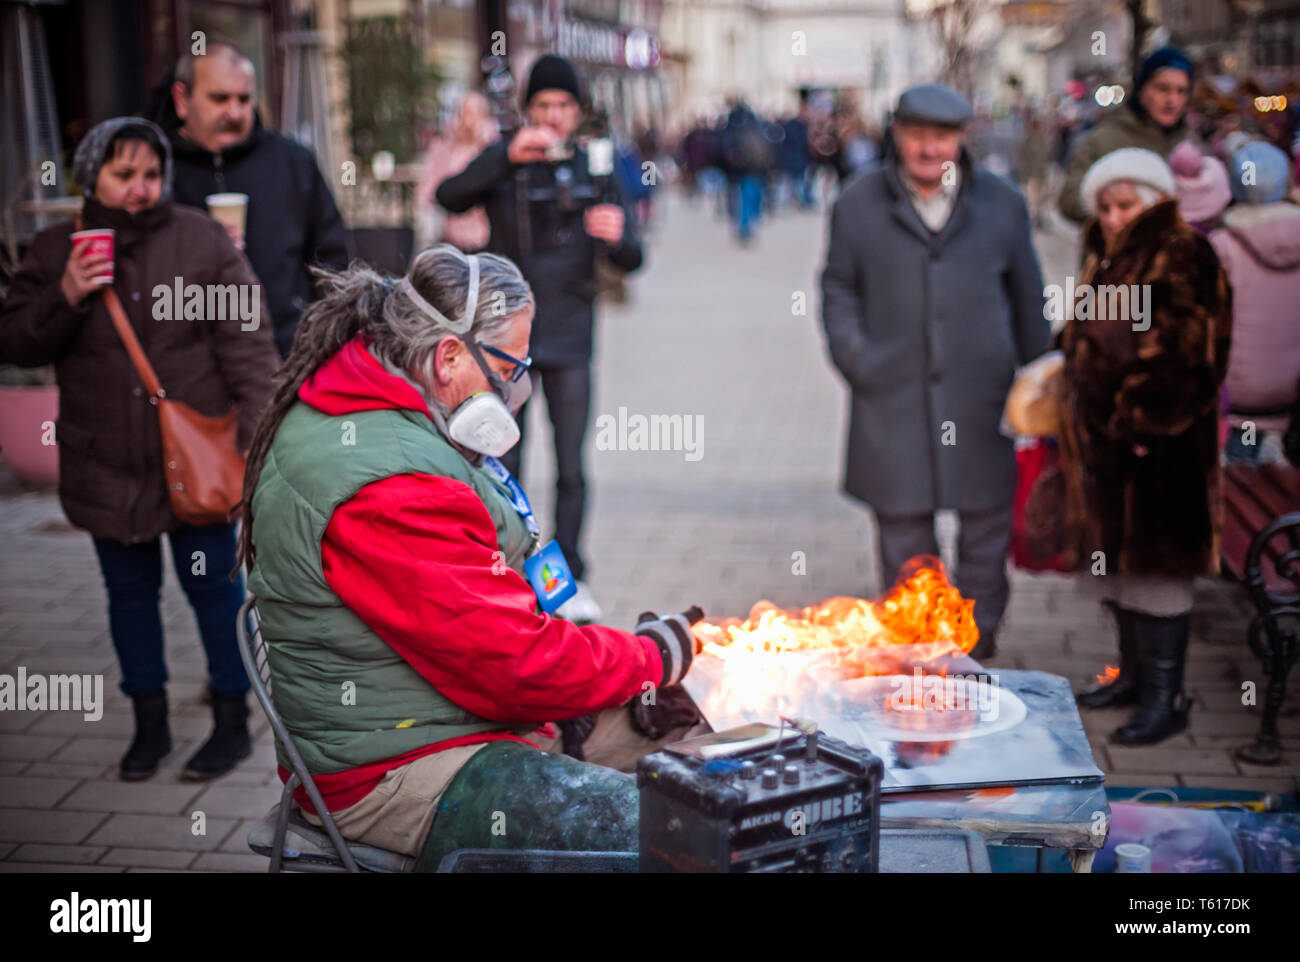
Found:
[95,524,248,697]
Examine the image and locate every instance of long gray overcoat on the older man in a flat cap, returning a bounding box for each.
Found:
[822,150,1050,515]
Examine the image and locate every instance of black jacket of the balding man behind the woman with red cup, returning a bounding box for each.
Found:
[163,114,352,358]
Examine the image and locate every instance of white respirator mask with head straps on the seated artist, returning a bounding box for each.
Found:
[399,254,533,458]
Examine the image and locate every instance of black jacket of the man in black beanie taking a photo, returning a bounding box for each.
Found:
[437,140,642,367]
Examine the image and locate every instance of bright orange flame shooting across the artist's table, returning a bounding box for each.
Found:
[694,555,979,676]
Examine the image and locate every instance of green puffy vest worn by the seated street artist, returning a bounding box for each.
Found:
[248,402,536,775]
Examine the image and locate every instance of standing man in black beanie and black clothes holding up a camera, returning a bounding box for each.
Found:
[437,53,642,621]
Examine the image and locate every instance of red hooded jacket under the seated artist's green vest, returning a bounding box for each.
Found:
[280,335,663,811]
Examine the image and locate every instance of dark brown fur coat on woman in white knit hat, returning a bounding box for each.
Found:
[1061,200,1232,576]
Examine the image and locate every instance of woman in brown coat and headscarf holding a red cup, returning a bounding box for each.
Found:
[0,117,278,780]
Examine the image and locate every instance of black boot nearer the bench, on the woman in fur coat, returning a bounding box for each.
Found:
[1110,611,1192,745]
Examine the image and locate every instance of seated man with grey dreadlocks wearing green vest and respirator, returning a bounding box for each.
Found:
[233,244,698,870]
